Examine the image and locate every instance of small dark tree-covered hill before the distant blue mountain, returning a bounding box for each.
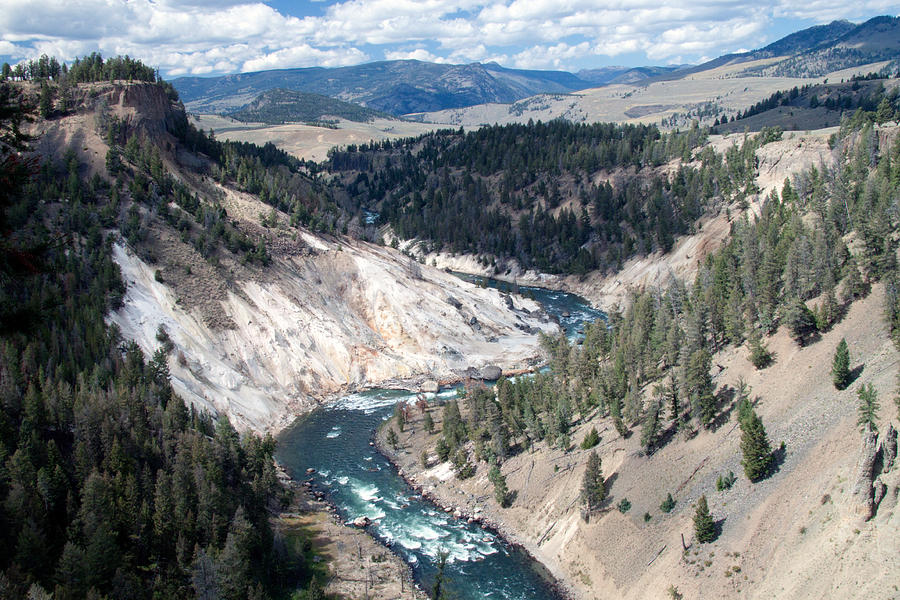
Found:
[228,88,388,125]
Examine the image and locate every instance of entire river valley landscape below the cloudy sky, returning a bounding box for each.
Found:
[0,10,900,600]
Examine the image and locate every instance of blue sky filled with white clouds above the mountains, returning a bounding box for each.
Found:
[0,0,900,78]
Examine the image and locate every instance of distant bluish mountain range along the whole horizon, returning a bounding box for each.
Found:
[172,16,900,116]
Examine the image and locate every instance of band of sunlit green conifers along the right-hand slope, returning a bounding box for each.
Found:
[426,116,900,465]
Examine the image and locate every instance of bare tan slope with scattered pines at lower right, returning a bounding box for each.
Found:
[384,286,900,599]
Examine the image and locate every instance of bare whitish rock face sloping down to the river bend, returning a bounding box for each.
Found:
[110,233,556,431]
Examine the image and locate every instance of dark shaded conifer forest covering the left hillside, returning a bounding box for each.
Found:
[0,56,330,599]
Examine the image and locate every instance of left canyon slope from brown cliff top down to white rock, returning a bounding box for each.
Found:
[35,82,556,431]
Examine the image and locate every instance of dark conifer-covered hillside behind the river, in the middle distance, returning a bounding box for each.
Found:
[327,120,778,274]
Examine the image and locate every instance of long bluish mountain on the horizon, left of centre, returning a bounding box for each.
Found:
[173,60,590,115]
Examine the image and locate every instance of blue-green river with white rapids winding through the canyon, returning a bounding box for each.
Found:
[276,280,603,600]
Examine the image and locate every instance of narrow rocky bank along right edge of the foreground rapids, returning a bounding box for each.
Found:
[373,406,577,600]
